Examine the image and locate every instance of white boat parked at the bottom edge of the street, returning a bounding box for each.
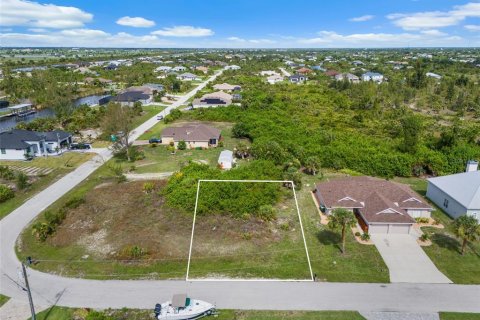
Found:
[154,294,216,320]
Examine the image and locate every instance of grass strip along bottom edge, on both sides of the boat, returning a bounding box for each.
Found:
[31,307,366,320]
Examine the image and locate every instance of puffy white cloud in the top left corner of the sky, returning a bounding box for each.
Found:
[0,0,93,29]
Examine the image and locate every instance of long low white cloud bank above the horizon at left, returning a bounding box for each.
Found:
[0,29,175,48]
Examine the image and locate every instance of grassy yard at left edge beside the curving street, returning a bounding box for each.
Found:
[0,152,93,219]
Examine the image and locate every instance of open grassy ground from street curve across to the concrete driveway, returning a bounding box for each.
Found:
[17,165,389,282]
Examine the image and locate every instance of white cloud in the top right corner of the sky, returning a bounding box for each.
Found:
[387,2,480,30]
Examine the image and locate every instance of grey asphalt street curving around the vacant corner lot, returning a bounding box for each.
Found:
[0,69,480,312]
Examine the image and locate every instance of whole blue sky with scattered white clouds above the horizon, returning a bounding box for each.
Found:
[0,0,480,48]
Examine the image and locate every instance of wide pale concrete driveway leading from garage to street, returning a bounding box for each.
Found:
[371,234,452,283]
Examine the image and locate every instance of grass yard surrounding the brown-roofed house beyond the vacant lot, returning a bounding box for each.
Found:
[131,121,248,173]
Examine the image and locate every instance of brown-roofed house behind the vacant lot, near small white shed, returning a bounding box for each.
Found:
[161,123,222,149]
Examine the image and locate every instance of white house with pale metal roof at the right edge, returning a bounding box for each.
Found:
[427,161,480,221]
